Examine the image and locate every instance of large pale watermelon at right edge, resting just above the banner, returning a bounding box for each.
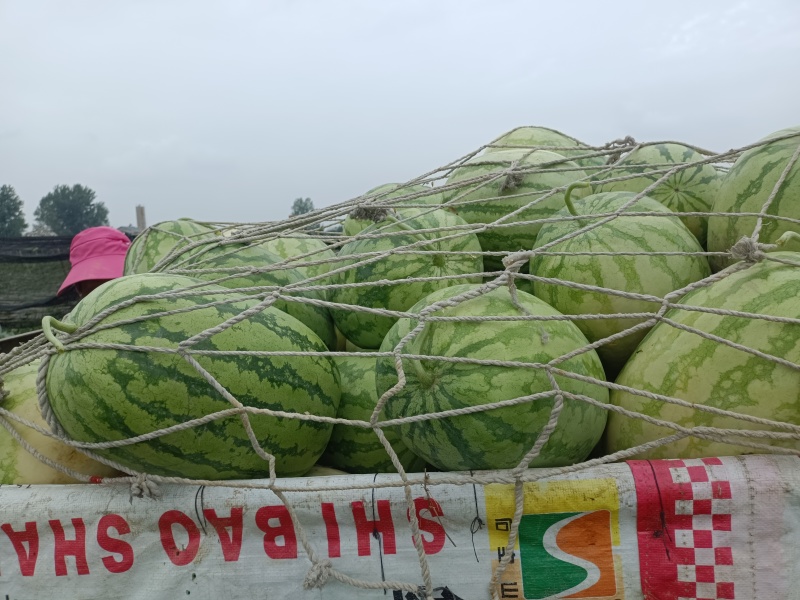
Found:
[605,252,800,458]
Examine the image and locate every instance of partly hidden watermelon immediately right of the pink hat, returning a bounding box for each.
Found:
[123,219,214,275]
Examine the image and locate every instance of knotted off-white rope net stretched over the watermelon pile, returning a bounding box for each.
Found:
[0,126,800,598]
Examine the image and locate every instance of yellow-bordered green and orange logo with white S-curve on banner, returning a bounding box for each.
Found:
[485,479,624,600]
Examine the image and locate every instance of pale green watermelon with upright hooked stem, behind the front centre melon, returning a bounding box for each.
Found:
[530,192,710,377]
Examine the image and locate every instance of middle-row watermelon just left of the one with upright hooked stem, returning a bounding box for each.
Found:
[328,208,482,349]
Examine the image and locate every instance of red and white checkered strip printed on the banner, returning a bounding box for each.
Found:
[669,458,735,600]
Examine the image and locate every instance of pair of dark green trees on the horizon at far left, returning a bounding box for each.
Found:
[0,184,108,237]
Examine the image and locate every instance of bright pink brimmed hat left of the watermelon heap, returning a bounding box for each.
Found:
[56,227,131,295]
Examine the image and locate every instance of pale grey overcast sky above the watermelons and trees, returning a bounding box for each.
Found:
[0,0,800,226]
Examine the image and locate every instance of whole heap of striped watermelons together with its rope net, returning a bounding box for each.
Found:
[0,127,800,591]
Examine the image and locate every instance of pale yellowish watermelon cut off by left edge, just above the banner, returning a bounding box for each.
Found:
[0,360,124,485]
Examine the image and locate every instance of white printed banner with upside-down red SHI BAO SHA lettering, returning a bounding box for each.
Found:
[0,456,800,600]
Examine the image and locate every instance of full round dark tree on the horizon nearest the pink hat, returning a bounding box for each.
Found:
[33,184,108,236]
